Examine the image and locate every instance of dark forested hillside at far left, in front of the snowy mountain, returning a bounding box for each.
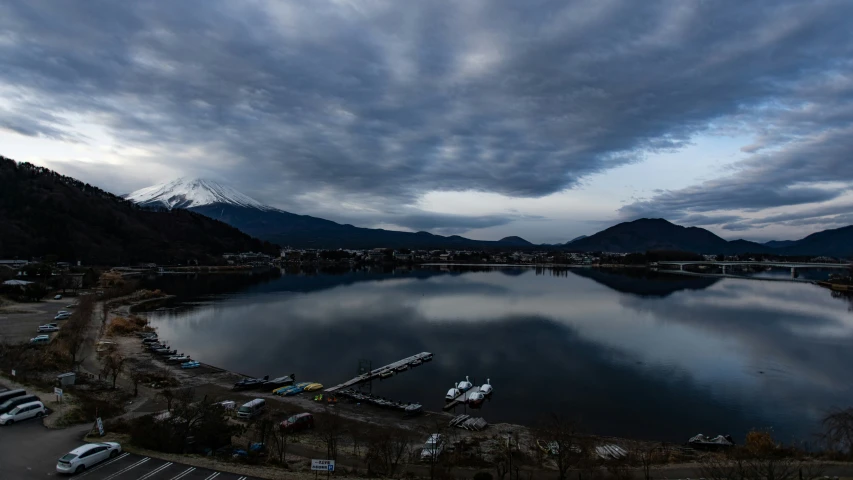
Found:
[0,157,278,265]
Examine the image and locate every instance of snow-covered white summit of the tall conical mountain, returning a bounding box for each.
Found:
[125,177,275,210]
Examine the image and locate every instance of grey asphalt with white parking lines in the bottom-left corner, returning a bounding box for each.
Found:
[0,398,254,480]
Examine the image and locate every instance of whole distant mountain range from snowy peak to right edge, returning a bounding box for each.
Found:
[125,178,853,257]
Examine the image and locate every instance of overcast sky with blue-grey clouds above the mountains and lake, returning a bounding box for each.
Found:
[0,0,853,243]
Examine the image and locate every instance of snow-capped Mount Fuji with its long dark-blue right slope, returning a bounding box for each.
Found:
[124,177,530,249]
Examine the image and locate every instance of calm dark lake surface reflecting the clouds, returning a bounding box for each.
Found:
[143,268,853,442]
